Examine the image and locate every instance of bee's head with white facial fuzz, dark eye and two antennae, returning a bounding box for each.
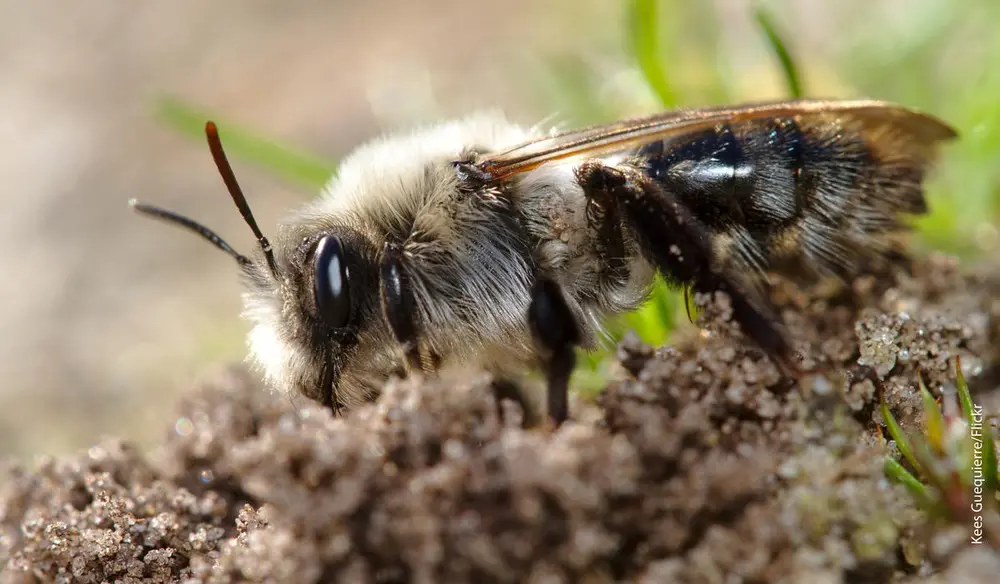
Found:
[136,122,393,409]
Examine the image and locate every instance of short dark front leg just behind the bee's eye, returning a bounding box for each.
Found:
[379,243,423,371]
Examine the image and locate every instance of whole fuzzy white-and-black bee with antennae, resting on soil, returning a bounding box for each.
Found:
[130,100,956,424]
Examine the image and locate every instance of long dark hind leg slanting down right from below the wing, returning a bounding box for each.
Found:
[577,160,797,374]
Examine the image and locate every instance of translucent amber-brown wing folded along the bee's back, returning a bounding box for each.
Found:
[476,99,957,180]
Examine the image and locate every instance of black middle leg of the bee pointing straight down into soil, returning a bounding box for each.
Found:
[528,277,581,426]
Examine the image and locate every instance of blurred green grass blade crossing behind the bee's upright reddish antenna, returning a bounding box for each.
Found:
[155,97,337,190]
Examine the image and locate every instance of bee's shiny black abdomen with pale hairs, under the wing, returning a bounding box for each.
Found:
[634,116,926,278]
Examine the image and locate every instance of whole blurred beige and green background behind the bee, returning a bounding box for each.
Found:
[0,0,1000,454]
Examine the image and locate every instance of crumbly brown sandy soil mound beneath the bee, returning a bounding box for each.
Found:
[0,256,1000,584]
